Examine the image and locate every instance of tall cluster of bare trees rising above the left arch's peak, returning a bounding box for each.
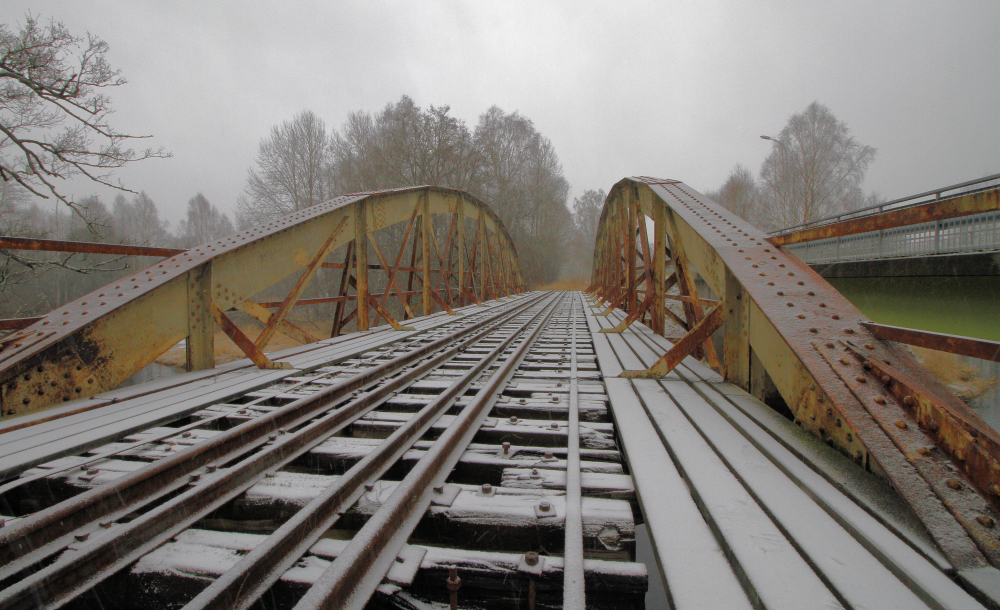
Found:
[236,96,589,286]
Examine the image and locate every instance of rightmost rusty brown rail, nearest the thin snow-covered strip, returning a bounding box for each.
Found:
[295,296,565,610]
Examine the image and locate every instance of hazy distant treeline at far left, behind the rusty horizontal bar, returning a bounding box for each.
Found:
[0,182,235,318]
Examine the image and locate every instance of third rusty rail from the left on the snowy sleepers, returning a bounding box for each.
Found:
[184,290,560,610]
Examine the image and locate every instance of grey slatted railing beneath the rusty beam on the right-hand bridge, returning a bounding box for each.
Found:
[787,212,1000,264]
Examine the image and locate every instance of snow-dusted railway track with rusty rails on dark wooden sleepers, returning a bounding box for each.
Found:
[0,293,647,609]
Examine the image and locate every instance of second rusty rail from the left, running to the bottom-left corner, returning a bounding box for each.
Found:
[0,290,541,608]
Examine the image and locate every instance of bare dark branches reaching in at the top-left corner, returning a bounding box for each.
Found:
[0,15,170,229]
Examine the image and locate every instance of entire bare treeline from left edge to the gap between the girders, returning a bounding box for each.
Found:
[0,96,604,318]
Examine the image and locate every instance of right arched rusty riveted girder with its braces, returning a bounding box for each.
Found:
[588,177,1000,574]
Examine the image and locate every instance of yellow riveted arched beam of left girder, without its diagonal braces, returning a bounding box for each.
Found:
[0,186,525,418]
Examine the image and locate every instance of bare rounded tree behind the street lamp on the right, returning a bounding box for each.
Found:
[760,102,876,228]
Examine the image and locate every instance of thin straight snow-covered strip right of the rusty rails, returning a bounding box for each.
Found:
[563,295,587,610]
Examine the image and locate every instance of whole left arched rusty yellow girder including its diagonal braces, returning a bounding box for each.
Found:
[0,186,526,418]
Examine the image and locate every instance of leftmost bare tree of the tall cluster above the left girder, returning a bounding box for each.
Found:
[236,110,333,228]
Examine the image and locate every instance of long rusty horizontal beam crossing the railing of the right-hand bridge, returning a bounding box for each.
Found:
[768,189,1000,246]
